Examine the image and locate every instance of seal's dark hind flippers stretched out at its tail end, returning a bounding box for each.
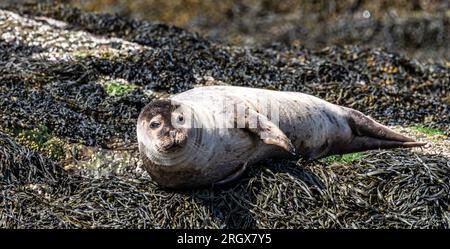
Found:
[345,108,426,152]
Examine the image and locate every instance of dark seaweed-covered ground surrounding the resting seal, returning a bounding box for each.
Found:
[0,4,450,228]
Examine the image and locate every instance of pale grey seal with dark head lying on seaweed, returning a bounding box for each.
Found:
[137,86,425,188]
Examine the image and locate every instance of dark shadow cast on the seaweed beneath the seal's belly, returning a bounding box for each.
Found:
[180,160,325,229]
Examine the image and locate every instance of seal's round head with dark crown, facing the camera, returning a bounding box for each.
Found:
[137,99,188,153]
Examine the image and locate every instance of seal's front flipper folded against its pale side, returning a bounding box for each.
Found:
[245,110,296,156]
